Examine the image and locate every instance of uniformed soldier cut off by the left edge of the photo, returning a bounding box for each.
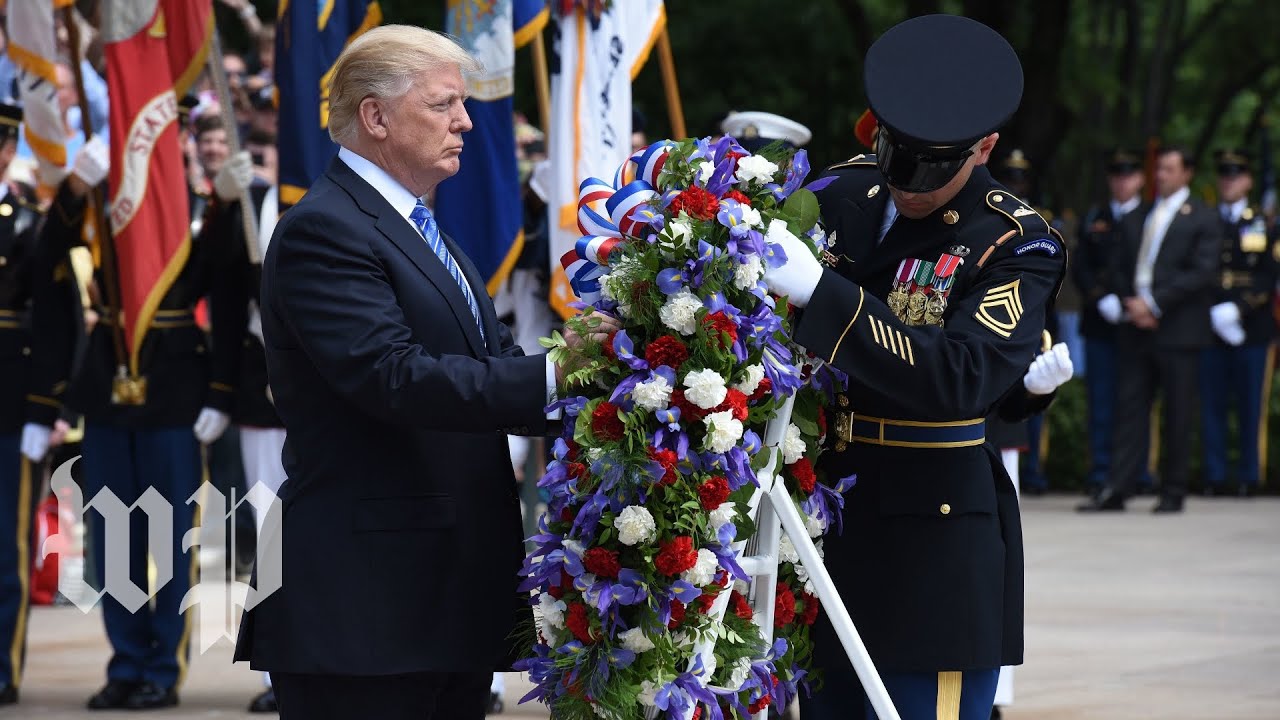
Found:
[0,105,78,705]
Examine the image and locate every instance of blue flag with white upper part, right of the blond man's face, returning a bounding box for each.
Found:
[434,0,548,295]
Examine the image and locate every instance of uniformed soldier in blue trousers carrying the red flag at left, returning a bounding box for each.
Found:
[44,113,238,710]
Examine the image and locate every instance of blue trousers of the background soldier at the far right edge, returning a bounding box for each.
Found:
[1199,343,1274,487]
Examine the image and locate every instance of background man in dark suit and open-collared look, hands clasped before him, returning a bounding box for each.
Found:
[1079,147,1222,512]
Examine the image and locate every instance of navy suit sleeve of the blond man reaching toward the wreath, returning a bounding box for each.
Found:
[262,207,547,434]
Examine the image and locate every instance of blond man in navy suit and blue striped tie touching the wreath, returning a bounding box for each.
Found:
[237,26,618,720]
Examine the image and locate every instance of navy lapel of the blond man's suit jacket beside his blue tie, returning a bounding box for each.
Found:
[328,158,489,357]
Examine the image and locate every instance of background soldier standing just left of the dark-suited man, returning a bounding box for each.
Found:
[1071,149,1152,496]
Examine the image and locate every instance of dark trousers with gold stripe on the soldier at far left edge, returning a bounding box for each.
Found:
[0,433,40,687]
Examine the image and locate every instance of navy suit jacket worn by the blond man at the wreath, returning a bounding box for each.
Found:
[236,159,547,675]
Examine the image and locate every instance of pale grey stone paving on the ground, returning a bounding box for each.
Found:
[12,497,1280,720]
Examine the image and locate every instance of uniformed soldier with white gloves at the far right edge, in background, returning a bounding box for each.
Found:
[1201,150,1280,496]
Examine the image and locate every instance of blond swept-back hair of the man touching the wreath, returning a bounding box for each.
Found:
[329,26,480,145]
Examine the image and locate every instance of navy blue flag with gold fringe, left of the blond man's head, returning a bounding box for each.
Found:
[275,0,383,210]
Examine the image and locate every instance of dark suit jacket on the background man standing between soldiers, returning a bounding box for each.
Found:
[1111,199,1222,348]
